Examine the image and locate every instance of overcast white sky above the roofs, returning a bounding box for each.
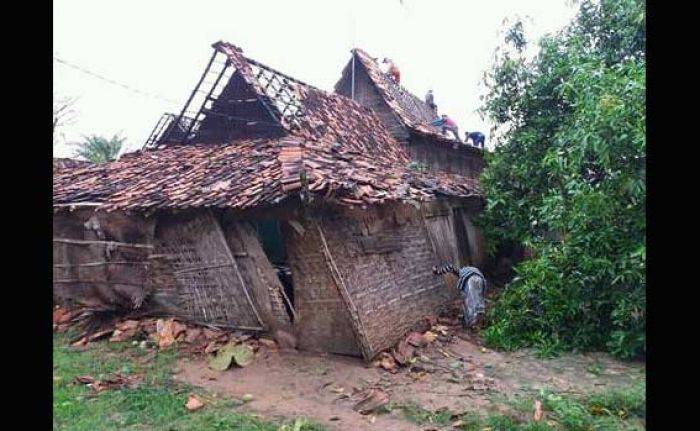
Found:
[53,0,575,157]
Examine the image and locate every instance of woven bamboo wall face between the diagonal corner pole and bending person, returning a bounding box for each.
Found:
[323,207,456,354]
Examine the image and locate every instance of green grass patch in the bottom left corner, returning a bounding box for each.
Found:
[53,334,323,431]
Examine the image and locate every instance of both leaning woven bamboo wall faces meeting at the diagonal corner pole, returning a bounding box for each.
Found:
[286,207,456,359]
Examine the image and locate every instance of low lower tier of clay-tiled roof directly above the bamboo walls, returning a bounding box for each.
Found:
[53,136,480,210]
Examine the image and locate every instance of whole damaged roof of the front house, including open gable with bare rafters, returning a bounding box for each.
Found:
[53,42,480,210]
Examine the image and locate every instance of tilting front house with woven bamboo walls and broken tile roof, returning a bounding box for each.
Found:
[53,42,483,360]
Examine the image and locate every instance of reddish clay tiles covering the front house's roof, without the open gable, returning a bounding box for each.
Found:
[53,42,481,211]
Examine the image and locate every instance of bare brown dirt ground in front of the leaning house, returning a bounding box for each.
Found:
[175,329,645,430]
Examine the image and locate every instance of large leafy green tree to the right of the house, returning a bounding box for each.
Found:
[481,0,646,358]
